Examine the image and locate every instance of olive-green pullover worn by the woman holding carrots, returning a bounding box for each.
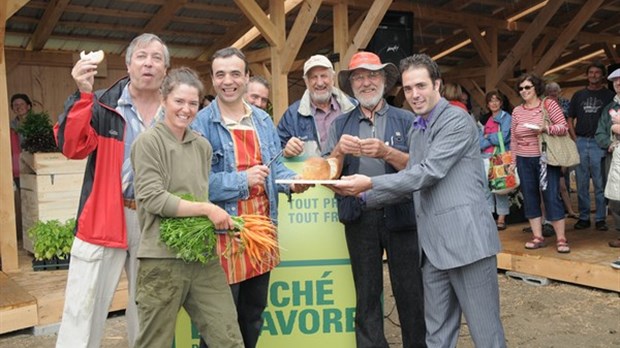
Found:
[131,122,212,258]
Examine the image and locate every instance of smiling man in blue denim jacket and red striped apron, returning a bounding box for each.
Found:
[192,47,307,348]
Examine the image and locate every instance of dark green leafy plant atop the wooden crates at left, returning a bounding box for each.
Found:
[17,111,58,153]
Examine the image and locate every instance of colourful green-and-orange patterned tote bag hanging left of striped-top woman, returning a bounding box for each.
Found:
[488,127,519,195]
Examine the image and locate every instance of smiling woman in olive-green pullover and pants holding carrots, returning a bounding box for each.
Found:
[131,68,243,348]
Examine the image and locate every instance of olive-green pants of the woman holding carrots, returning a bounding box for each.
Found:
[136,258,243,348]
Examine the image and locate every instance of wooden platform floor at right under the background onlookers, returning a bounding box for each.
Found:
[497,219,620,292]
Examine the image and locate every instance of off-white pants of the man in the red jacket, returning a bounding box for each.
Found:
[56,208,140,348]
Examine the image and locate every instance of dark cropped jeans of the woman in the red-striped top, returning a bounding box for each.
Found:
[517,156,566,221]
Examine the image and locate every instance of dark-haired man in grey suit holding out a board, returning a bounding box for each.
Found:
[334,54,506,348]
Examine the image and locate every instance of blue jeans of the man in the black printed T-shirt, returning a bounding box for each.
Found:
[575,137,605,221]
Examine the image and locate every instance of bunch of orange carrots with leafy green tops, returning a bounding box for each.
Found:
[160,215,278,268]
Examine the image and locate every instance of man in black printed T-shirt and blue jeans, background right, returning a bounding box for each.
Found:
[568,62,614,231]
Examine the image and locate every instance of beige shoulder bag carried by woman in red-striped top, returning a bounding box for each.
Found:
[540,98,579,167]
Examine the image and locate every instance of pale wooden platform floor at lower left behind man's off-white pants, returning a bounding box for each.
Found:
[0,249,127,332]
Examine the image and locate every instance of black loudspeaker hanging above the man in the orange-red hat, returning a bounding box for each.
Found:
[366,11,413,67]
